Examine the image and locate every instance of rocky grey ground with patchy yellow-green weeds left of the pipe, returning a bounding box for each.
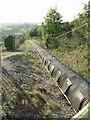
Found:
[2,49,75,120]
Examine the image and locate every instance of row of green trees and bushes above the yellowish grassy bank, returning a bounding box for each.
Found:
[24,4,89,48]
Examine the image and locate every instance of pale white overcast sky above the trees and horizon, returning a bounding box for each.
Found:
[0,0,89,23]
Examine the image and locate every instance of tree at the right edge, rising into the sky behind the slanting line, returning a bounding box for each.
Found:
[72,4,89,46]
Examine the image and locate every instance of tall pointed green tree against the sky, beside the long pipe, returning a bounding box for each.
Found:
[42,8,62,47]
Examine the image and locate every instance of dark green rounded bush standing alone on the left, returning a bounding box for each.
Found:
[4,35,15,50]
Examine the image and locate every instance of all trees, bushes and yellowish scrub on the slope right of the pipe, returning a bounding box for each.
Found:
[9,4,90,81]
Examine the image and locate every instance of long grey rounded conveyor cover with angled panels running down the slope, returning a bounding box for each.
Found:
[29,41,90,112]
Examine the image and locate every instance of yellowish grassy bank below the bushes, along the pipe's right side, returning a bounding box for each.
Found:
[36,40,90,81]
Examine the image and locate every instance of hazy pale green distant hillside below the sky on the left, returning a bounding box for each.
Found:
[0,23,39,41]
